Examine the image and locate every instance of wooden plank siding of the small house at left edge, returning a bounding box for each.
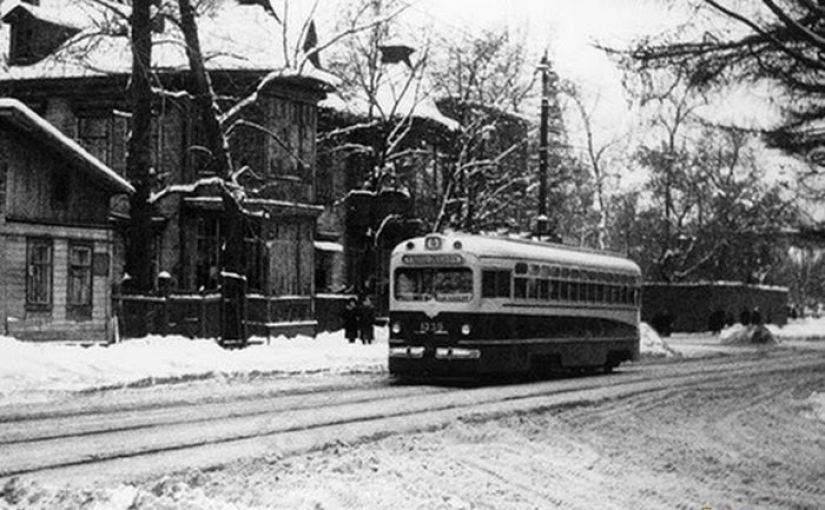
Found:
[0,116,113,341]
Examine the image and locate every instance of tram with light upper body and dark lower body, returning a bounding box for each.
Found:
[389,234,641,377]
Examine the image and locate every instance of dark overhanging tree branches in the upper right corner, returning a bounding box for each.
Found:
[608,0,825,195]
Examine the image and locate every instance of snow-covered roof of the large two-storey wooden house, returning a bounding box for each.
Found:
[0,0,337,88]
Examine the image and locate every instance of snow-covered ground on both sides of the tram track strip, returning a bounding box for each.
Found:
[0,319,825,510]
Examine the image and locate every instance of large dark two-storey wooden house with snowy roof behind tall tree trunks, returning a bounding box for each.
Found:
[0,0,334,334]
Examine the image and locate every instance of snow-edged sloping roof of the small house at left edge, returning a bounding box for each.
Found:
[0,98,135,193]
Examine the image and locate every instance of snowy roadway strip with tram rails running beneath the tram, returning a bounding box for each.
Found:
[0,350,825,498]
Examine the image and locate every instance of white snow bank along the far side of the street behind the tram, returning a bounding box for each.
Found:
[0,319,825,404]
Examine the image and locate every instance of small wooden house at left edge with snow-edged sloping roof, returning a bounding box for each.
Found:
[0,99,134,342]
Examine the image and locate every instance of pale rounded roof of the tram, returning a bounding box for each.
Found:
[394,234,641,274]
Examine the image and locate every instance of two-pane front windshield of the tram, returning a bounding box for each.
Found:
[395,267,473,301]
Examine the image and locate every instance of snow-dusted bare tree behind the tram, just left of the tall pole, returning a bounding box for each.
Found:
[424,28,548,231]
